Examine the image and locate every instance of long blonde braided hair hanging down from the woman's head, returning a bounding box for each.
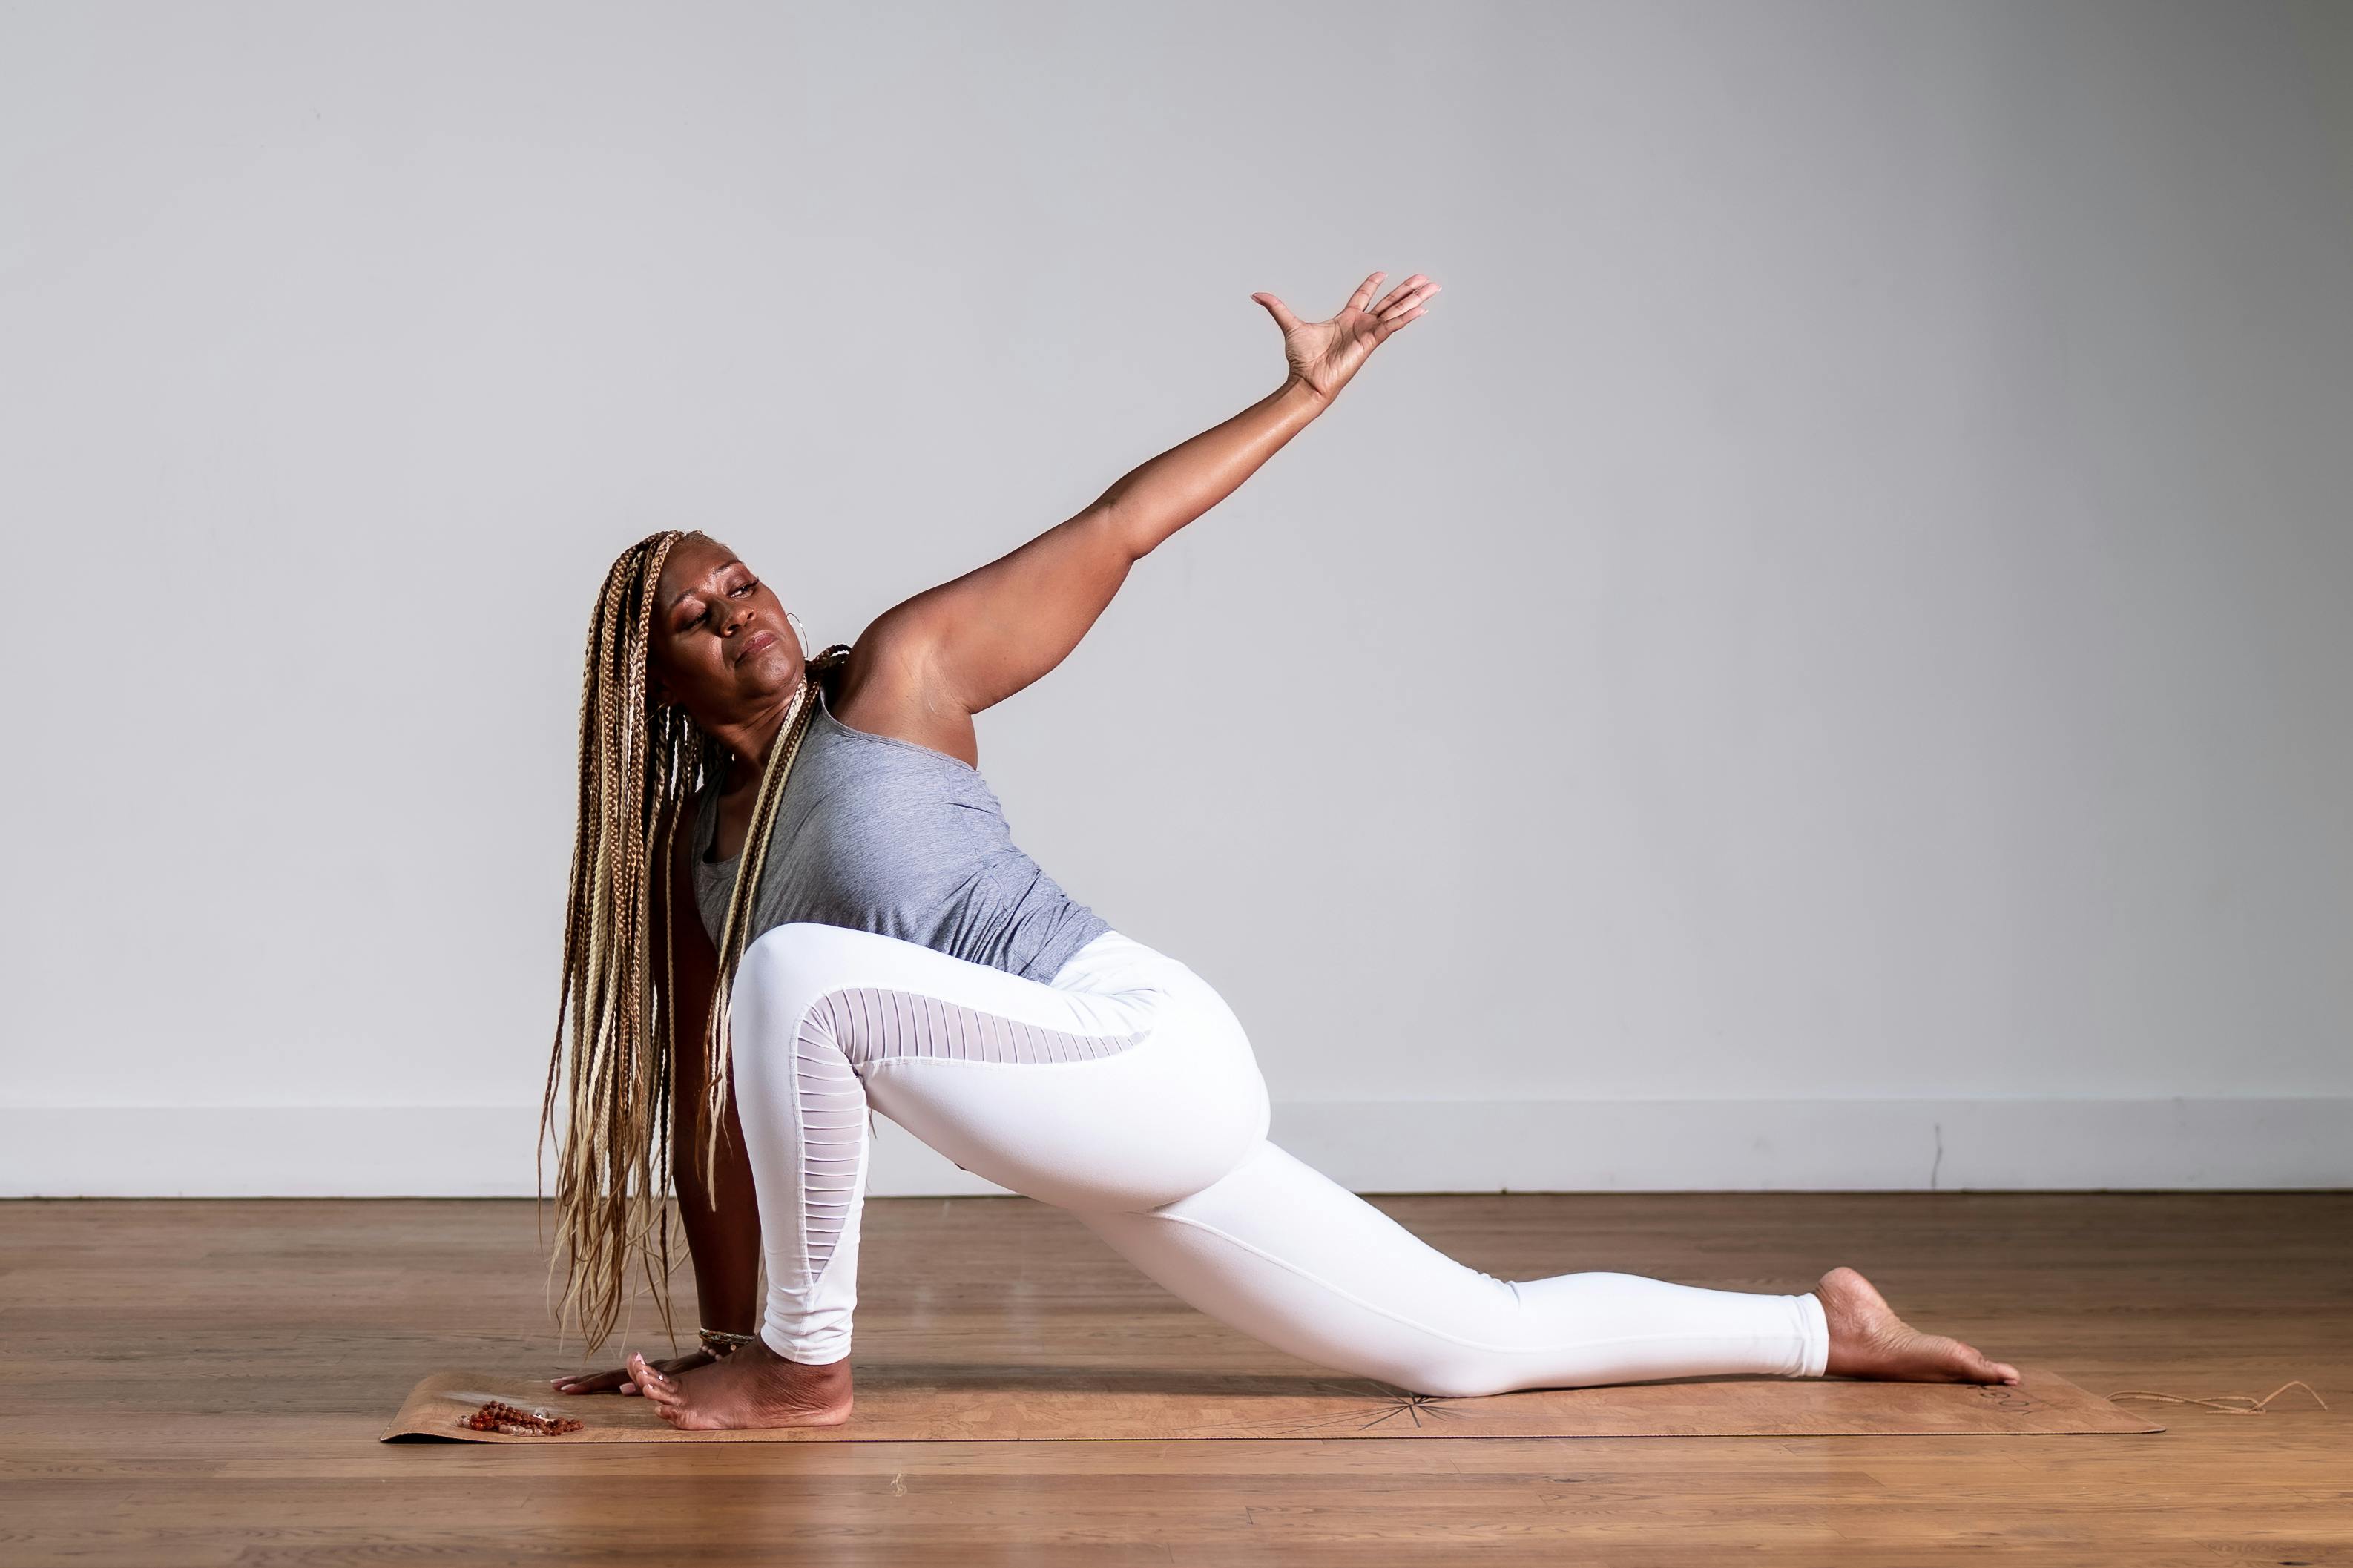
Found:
[539,530,849,1356]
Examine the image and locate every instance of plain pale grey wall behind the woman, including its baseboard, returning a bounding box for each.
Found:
[0,2,2353,1193]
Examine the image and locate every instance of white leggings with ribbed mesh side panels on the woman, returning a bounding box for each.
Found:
[729,923,1831,1396]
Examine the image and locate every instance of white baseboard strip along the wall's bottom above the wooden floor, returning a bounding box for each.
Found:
[0,1097,2353,1199]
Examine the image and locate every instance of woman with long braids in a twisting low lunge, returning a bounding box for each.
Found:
[546,273,2016,1427]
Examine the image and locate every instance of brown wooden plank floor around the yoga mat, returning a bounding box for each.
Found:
[0,1193,2353,1568]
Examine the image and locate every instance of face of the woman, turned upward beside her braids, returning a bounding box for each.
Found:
[647,535,807,730]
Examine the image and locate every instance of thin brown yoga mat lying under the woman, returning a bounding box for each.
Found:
[384,1363,2165,1443]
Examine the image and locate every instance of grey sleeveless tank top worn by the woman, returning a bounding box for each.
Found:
[692,676,1110,982]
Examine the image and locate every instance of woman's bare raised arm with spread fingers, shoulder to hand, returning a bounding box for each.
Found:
[875,273,1438,714]
